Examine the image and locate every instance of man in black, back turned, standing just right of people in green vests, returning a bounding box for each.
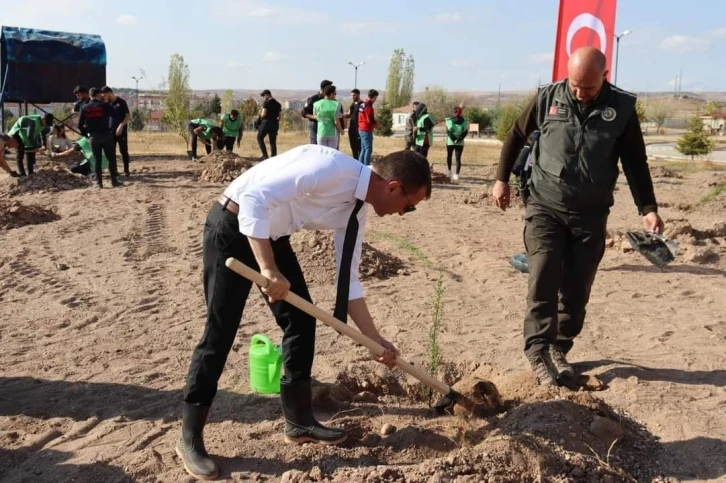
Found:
[78,87,123,188]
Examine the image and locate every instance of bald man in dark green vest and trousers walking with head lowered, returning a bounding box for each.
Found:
[492,47,663,385]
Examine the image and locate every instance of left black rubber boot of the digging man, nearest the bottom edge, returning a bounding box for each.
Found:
[176,404,219,480]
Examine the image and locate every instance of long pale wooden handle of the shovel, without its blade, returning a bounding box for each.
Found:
[226,257,451,396]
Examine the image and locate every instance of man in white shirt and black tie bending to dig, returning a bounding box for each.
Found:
[176,144,431,479]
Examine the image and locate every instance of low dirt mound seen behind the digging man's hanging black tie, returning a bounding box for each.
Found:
[291,230,409,285]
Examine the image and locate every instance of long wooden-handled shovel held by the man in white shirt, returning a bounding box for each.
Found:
[226,258,490,413]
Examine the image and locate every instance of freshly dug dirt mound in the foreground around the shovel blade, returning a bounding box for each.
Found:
[281,367,665,483]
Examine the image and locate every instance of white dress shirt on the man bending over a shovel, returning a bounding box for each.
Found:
[224,144,371,300]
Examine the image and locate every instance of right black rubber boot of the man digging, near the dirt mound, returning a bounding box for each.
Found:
[280,379,348,444]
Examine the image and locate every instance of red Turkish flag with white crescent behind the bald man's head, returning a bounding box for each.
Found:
[552,0,617,82]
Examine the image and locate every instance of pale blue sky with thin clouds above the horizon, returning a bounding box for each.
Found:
[0,0,726,94]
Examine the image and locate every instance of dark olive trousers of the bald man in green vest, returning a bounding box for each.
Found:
[524,202,608,354]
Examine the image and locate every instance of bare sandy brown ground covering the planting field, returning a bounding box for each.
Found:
[0,155,726,483]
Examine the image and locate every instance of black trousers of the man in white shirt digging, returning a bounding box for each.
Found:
[184,203,315,405]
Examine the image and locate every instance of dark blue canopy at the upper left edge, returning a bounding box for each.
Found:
[0,27,106,130]
